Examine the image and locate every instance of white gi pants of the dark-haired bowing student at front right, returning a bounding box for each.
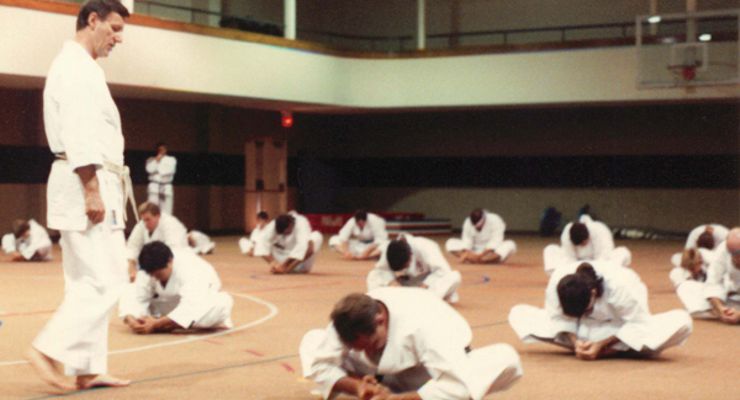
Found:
[509,304,693,356]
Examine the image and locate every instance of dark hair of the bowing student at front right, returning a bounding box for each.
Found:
[558,263,604,317]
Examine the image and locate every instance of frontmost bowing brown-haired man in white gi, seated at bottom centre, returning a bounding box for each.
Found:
[299,288,522,400]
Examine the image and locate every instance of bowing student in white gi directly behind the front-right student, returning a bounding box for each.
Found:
[543,215,632,275]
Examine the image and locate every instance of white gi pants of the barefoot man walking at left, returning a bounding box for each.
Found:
[33,224,128,376]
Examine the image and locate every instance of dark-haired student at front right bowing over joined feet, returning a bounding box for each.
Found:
[509,261,692,360]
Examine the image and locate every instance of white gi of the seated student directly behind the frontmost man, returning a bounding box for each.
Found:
[367,234,462,300]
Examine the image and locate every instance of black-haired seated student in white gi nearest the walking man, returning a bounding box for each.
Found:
[119,241,234,334]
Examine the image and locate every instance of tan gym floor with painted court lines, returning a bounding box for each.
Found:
[0,236,740,400]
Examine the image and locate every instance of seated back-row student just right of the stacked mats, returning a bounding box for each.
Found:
[445,208,516,264]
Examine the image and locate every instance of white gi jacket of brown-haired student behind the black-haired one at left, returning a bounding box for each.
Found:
[126,212,188,260]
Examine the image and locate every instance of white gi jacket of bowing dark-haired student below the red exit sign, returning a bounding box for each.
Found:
[254,211,318,262]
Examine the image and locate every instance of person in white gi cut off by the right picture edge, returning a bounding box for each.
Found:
[704,227,740,325]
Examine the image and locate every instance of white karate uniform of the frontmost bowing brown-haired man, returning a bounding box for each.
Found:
[300,288,521,400]
